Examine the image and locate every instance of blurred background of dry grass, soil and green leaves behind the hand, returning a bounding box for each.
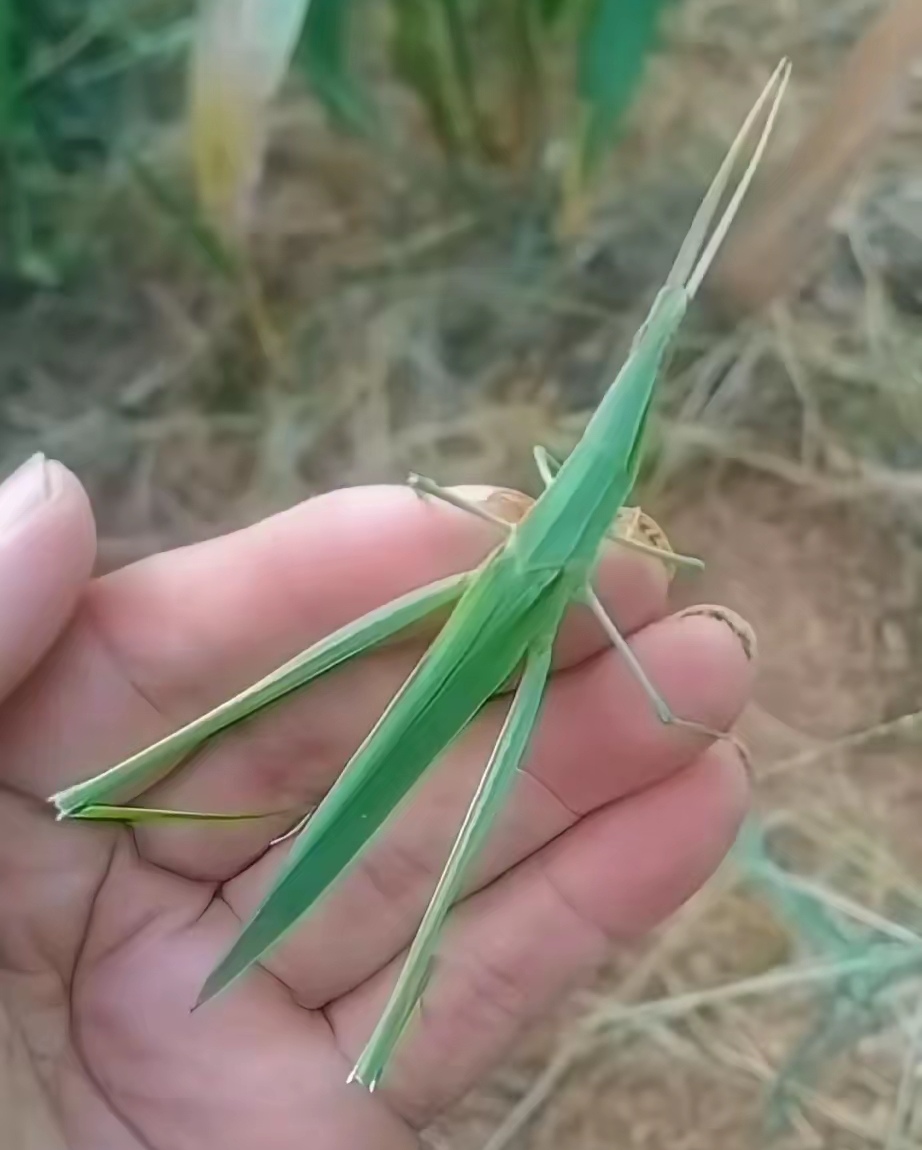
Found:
[0,0,922,1150]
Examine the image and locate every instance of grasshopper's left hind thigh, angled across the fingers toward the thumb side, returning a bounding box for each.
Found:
[51,572,472,820]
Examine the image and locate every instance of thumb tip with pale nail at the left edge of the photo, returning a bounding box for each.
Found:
[0,454,95,699]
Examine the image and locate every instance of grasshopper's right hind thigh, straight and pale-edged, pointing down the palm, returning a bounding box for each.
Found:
[351,633,554,1090]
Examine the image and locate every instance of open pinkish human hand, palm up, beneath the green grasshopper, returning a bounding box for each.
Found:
[0,462,753,1150]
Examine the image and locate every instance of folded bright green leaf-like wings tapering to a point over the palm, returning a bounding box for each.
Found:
[199,551,568,1003]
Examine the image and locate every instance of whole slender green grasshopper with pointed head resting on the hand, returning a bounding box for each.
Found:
[51,61,790,1089]
